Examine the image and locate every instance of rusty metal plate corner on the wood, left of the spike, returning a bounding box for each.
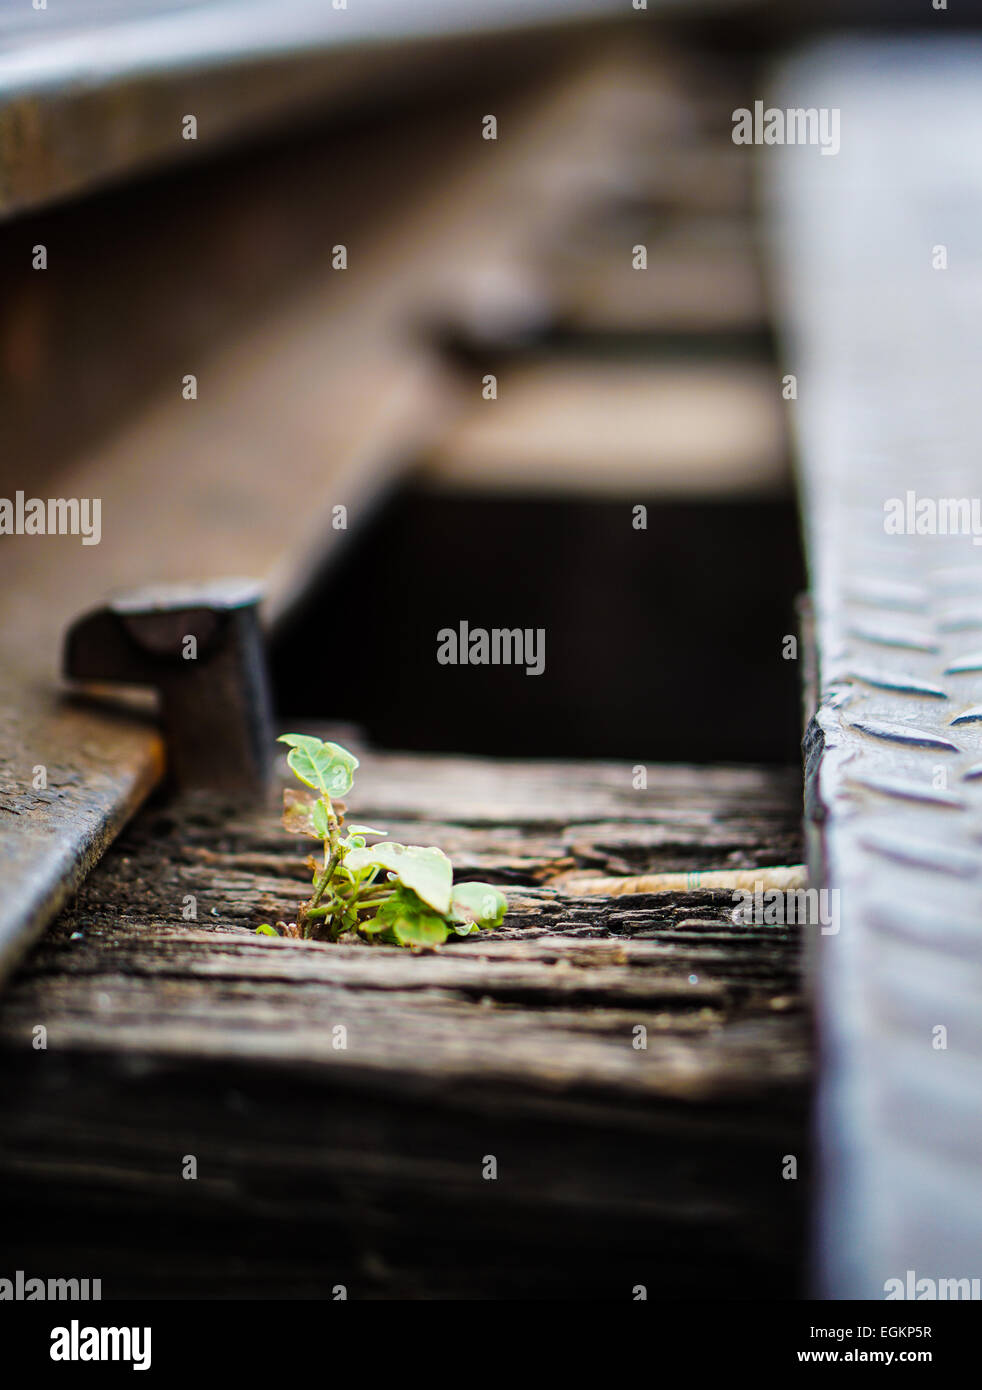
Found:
[0,677,164,980]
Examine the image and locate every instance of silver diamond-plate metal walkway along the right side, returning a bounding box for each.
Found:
[762,39,982,1298]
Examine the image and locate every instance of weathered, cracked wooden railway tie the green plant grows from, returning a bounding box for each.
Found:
[0,755,810,1298]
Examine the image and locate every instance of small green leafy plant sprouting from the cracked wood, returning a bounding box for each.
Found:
[256,734,506,947]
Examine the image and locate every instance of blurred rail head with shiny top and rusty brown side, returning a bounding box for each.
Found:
[0,0,634,217]
